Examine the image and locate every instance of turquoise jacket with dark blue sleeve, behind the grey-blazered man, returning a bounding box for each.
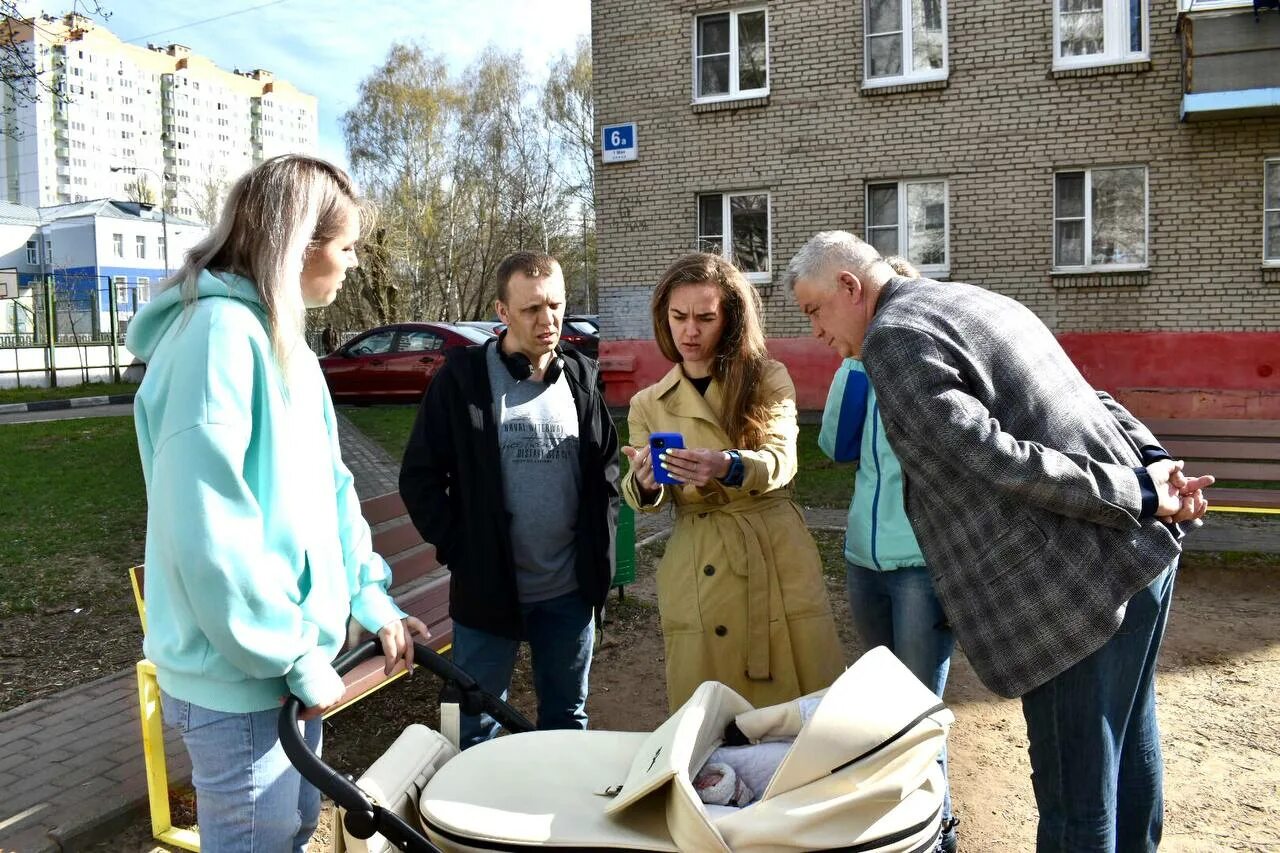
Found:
[818,359,924,571]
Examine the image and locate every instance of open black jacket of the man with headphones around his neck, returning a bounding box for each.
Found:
[399,341,620,639]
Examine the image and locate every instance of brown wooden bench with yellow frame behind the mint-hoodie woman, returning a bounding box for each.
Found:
[129,492,453,850]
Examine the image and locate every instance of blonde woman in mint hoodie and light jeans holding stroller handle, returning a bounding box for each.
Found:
[128,155,428,853]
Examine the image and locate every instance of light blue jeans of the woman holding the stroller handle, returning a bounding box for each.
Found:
[160,692,323,853]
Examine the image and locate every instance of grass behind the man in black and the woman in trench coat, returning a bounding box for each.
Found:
[338,405,854,507]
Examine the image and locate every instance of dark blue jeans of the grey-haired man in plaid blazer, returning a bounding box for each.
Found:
[1023,561,1178,853]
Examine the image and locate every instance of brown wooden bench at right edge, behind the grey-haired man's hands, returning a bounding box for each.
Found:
[1143,418,1280,514]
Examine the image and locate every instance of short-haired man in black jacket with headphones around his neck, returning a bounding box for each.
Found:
[399,252,618,748]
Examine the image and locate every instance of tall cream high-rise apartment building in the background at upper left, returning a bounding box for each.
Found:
[0,15,317,219]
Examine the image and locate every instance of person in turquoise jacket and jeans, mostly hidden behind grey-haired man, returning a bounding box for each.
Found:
[818,257,959,853]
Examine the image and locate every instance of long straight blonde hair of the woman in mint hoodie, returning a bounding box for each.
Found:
[161,154,372,373]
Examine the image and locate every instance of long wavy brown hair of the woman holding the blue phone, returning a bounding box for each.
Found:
[652,252,769,450]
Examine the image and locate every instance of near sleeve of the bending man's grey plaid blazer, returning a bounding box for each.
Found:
[863,327,1143,530]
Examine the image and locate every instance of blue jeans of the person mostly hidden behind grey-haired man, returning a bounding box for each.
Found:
[845,560,955,820]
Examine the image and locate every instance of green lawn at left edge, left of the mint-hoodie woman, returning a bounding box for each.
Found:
[0,418,147,617]
